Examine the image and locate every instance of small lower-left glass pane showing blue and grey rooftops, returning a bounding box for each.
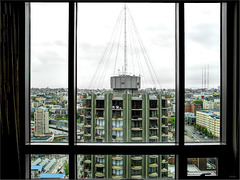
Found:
[31,154,69,179]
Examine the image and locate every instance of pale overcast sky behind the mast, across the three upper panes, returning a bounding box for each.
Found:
[31,3,220,89]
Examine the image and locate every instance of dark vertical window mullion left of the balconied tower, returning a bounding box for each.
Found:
[68,2,77,179]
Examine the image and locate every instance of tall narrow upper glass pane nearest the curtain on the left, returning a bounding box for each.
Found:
[30,3,68,142]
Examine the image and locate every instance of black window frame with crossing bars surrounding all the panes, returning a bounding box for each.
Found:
[17,0,240,179]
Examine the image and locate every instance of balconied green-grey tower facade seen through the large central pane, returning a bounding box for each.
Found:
[78,93,171,142]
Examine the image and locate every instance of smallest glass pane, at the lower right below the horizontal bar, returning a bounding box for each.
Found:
[187,158,217,176]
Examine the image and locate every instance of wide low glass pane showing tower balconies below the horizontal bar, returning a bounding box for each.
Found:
[77,154,175,179]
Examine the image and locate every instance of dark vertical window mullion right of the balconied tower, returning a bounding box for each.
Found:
[175,2,187,179]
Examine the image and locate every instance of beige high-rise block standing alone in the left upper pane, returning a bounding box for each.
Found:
[34,109,49,136]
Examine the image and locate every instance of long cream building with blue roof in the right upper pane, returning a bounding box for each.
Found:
[196,110,220,138]
